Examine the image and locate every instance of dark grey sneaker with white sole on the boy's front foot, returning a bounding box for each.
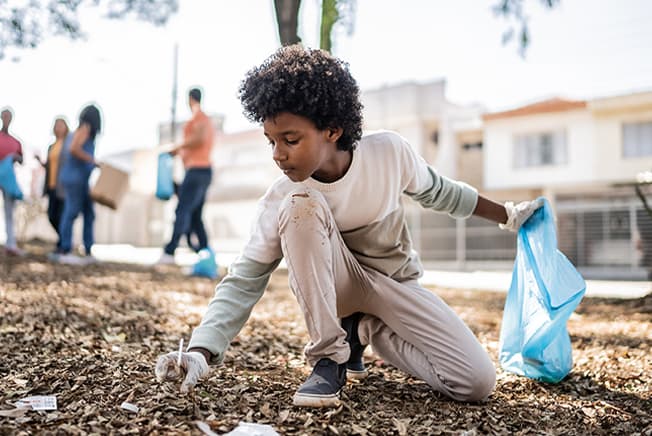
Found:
[293,358,346,407]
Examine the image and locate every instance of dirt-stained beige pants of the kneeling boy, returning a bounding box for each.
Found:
[279,188,496,401]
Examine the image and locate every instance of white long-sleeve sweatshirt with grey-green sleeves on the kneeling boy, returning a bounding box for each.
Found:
[189,131,478,362]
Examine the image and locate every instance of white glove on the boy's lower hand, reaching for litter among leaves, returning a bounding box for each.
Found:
[155,351,209,393]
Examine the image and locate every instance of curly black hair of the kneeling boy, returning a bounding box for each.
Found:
[238,44,362,150]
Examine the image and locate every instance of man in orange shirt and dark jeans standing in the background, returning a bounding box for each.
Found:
[159,88,214,264]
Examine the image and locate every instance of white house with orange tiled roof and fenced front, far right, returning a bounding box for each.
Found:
[484,92,652,278]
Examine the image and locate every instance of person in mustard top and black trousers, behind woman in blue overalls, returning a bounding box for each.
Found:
[35,117,70,253]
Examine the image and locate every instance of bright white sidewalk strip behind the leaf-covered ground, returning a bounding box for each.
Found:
[93,244,652,298]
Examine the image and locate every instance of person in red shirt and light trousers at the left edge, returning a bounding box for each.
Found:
[0,108,25,256]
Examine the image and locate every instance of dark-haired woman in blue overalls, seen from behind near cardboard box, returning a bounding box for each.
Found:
[56,104,102,265]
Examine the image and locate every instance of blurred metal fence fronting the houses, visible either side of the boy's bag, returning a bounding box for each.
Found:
[406,194,652,280]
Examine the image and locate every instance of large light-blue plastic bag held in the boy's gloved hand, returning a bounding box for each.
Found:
[499,201,586,383]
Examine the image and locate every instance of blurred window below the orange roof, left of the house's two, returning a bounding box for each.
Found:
[514,131,567,168]
